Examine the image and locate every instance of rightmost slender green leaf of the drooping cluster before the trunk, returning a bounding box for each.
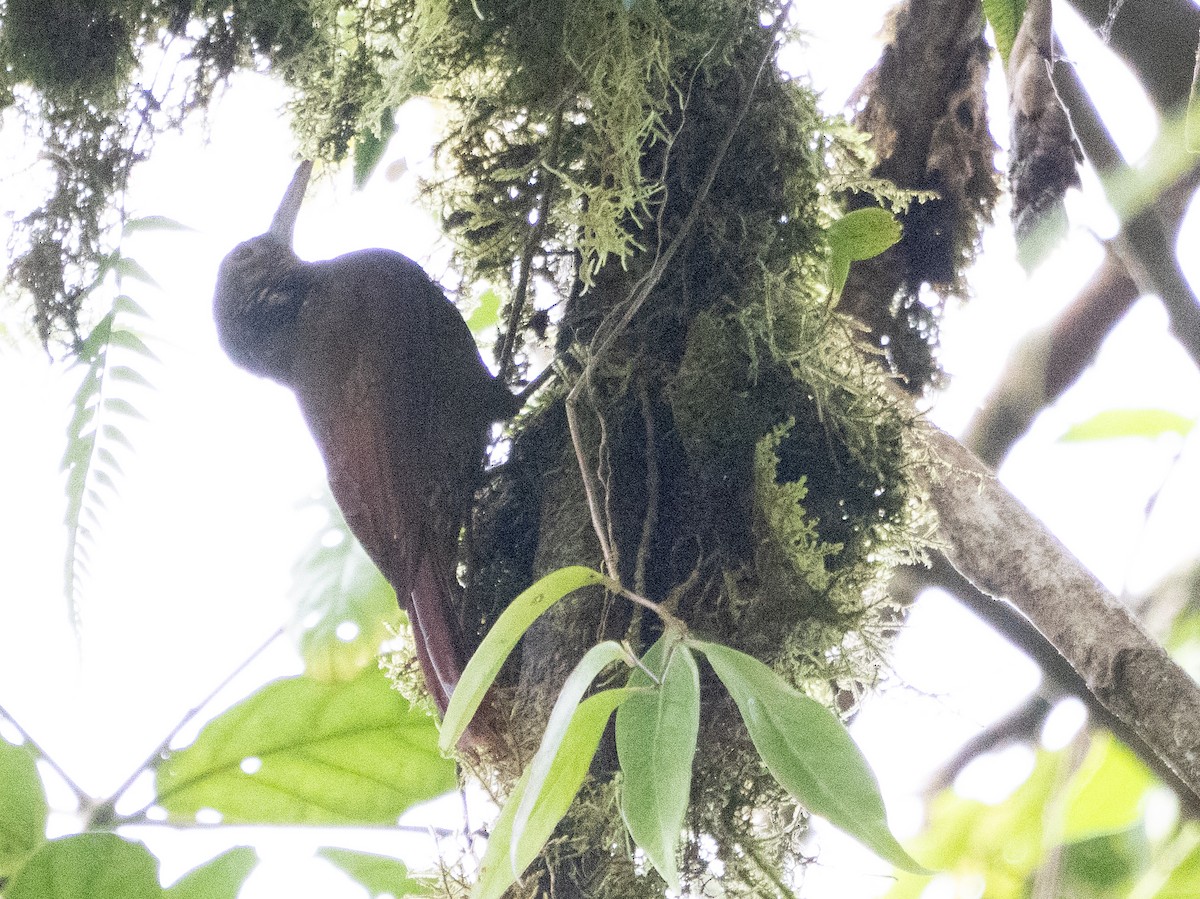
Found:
[691,641,925,874]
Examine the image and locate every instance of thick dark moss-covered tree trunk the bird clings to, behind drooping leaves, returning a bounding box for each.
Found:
[445,4,940,897]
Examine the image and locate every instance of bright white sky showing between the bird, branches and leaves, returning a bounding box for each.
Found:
[0,0,1200,899]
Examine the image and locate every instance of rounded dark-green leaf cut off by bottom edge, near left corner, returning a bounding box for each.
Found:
[5,833,163,899]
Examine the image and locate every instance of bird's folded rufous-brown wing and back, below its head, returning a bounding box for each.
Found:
[294,257,463,708]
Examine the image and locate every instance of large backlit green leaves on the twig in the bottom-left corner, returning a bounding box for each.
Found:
[0,669,446,899]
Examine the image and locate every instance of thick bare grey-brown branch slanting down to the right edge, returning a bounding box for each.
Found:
[893,396,1200,798]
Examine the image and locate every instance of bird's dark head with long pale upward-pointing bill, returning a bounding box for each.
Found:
[212,160,312,382]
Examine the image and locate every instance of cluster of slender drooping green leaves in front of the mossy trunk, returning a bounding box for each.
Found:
[442,567,924,899]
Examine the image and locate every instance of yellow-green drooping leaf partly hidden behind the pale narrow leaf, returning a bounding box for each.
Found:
[472,689,634,899]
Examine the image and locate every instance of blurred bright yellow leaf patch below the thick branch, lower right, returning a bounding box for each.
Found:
[1061,732,1154,843]
